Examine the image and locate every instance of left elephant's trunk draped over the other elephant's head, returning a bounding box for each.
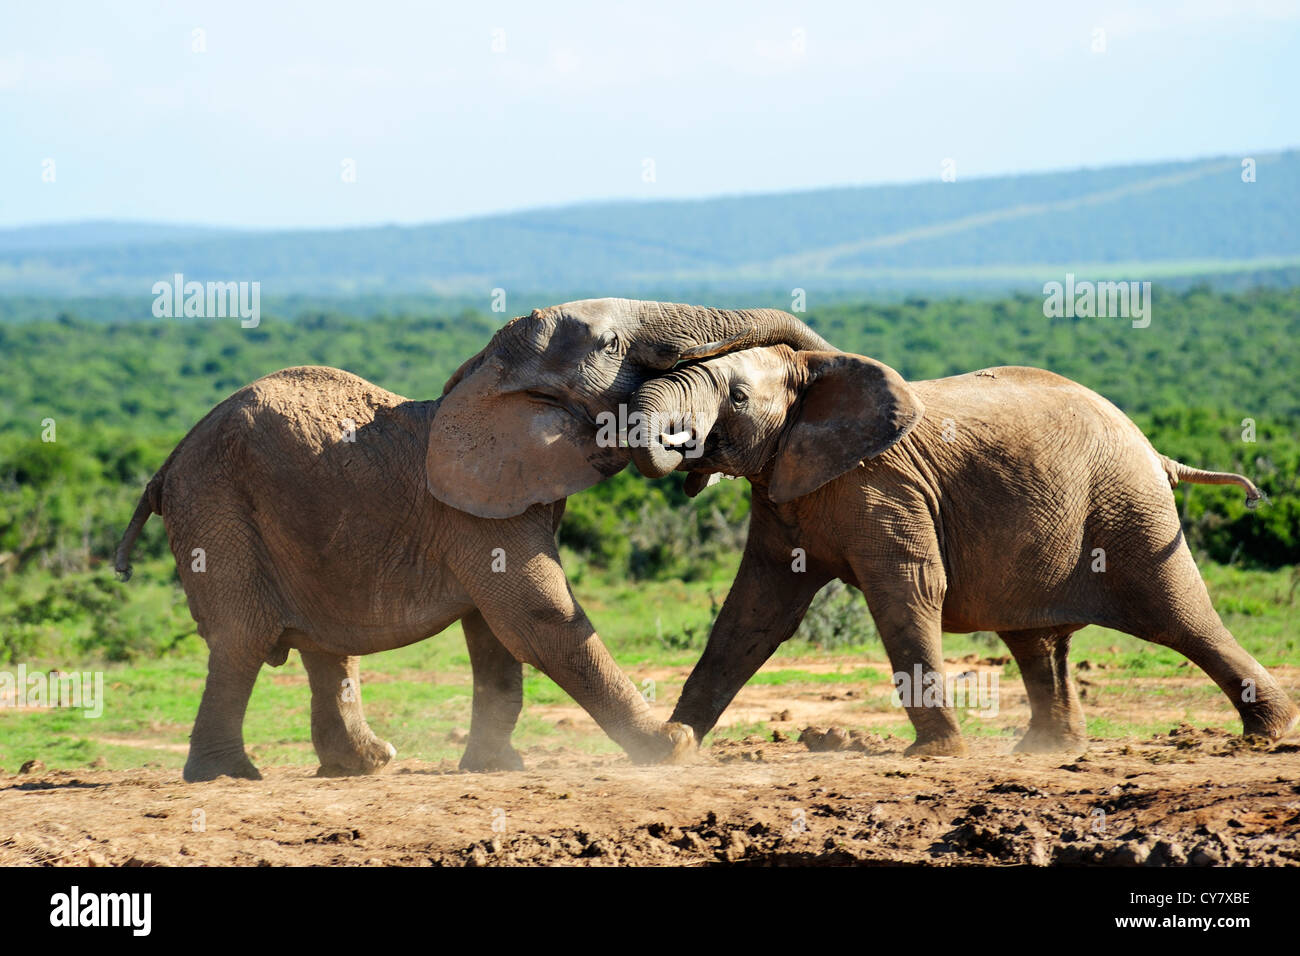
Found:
[637,302,839,369]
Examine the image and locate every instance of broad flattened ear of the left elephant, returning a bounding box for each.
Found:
[425,356,629,518]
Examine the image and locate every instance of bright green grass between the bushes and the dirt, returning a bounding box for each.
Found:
[0,562,1300,773]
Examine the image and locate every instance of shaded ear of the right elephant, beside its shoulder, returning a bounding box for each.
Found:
[767,352,926,505]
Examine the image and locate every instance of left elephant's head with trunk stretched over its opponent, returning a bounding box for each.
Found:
[426,299,832,518]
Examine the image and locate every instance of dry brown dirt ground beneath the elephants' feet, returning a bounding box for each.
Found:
[0,661,1300,866]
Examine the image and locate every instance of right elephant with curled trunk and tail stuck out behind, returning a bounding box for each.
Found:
[632,347,1297,754]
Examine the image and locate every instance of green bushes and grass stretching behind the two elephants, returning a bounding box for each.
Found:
[0,287,1300,769]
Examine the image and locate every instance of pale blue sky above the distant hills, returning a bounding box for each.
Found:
[0,0,1300,226]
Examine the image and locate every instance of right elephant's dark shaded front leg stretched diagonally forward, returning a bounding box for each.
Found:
[668,548,828,741]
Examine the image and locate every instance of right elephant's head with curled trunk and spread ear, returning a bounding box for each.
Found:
[632,346,924,505]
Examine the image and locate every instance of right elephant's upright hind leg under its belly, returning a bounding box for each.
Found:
[998,628,1088,753]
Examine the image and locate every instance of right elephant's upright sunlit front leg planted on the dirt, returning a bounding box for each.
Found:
[867,572,966,757]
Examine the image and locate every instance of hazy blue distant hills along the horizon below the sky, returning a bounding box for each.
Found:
[0,151,1300,298]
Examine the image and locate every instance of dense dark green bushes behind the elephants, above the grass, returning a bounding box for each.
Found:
[0,289,1300,598]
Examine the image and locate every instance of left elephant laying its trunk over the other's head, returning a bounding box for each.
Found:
[116,299,828,780]
